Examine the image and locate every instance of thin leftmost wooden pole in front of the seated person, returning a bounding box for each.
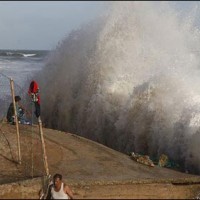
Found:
[10,79,21,164]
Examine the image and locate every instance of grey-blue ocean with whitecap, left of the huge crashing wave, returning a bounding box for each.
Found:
[0,50,48,118]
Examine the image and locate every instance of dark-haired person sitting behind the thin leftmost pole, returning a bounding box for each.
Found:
[6,96,31,125]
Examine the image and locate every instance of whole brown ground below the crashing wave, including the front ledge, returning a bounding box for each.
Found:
[0,123,200,198]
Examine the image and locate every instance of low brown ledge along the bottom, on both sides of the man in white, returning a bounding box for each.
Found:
[0,178,200,199]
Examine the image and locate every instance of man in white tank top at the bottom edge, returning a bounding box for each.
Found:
[51,174,73,199]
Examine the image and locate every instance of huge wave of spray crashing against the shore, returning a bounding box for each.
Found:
[36,2,200,173]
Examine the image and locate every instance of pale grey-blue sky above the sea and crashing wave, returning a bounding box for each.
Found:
[0,1,199,49]
